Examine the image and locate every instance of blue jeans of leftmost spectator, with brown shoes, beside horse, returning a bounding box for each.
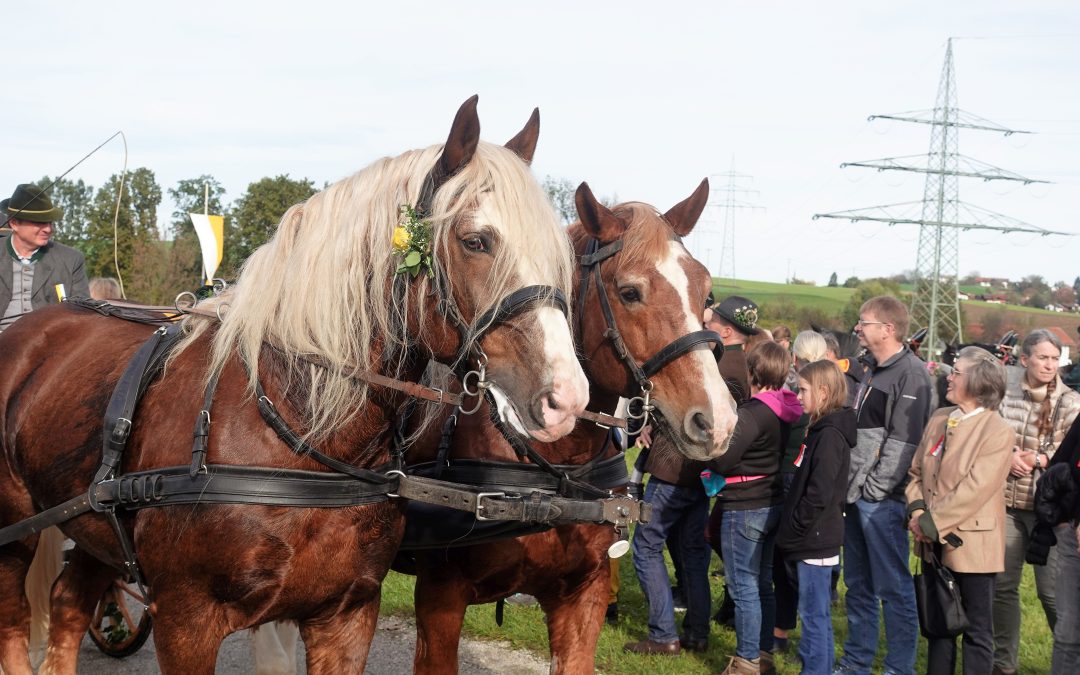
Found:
[634,476,712,643]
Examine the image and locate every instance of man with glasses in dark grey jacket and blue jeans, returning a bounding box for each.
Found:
[835,296,930,675]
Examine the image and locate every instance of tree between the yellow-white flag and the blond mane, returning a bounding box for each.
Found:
[221,174,316,275]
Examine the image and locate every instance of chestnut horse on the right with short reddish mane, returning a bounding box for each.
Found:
[395,180,735,673]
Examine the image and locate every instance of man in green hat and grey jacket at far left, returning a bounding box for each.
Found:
[0,183,90,330]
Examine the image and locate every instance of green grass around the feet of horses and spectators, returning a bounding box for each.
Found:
[382,444,1053,675]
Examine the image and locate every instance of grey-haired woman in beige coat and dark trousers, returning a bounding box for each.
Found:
[906,347,1013,675]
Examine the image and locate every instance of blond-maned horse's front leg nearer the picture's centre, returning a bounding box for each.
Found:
[300,593,379,675]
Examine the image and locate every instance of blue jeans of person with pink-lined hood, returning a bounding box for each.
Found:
[720,505,781,659]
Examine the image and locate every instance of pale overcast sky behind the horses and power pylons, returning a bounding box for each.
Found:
[0,0,1080,284]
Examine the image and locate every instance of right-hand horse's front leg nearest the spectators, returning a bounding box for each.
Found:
[537,556,610,675]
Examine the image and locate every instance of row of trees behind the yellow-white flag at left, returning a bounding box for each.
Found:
[38,167,316,303]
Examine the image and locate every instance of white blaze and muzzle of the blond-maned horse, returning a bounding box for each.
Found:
[473,195,589,443]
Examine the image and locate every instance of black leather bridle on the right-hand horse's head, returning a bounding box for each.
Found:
[578,238,720,427]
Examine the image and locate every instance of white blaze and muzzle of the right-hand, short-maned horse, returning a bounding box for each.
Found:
[654,241,738,460]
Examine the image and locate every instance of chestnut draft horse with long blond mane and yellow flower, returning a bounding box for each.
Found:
[0,97,588,675]
